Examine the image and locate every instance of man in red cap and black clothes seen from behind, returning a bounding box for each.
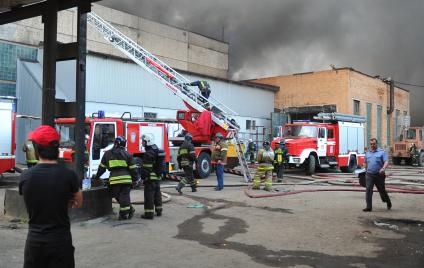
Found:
[19,125,82,267]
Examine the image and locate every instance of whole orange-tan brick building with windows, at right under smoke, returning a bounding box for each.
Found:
[254,68,409,147]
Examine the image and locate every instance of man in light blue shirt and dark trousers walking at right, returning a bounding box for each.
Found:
[363,138,392,212]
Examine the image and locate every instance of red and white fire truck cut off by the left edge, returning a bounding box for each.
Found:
[0,97,16,174]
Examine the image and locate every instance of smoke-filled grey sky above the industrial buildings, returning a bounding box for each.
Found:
[100,0,424,126]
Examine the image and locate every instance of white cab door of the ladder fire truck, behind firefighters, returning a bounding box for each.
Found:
[88,122,116,179]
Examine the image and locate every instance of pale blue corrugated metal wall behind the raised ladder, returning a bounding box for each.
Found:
[87,56,274,118]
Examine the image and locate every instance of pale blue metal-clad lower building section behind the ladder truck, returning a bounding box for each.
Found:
[16,50,277,162]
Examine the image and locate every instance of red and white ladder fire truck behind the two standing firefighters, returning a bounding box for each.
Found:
[56,110,225,178]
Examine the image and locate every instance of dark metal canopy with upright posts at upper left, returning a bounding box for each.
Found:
[0,0,99,179]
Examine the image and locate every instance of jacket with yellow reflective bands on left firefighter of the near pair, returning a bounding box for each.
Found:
[96,147,137,185]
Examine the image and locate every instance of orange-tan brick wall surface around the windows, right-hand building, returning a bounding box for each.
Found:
[253,68,409,147]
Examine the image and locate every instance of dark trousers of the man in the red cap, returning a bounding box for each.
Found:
[24,238,75,268]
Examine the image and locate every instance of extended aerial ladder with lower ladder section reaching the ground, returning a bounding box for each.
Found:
[87,12,251,181]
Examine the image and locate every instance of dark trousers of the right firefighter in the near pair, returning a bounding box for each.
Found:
[144,180,162,216]
